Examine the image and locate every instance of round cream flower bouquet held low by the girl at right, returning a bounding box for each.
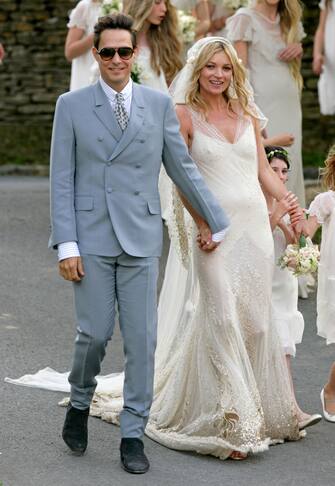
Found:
[278,235,320,277]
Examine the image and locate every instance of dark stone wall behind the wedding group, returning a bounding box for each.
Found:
[0,0,335,164]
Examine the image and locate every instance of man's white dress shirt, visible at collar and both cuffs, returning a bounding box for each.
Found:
[58,77,227,261]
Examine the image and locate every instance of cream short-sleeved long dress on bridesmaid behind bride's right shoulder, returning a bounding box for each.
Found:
[226,8,305,207]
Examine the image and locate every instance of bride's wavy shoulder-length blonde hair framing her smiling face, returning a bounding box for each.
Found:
[185,41,255,116]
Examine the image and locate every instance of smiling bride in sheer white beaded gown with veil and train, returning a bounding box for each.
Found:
[6,37,299,459]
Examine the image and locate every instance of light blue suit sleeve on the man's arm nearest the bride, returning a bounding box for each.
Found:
[163,100,229,233]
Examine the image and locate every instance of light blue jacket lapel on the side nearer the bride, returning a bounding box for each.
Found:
[109,83,145,160]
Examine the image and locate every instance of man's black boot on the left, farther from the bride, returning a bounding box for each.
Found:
[62,404,90,455]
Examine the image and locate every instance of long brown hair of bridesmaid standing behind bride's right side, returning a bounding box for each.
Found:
[257,0,303,89]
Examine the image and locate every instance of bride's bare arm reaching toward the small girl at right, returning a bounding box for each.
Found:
[253,119,302,223]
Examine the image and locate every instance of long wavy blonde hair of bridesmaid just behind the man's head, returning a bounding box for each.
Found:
[123,0,182,84]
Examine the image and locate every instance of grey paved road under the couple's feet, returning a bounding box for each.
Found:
[0,177,335,486]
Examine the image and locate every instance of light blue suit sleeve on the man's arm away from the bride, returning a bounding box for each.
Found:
[49,96,78,248]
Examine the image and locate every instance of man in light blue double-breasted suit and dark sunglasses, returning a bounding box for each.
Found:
[50,14,228,473]
